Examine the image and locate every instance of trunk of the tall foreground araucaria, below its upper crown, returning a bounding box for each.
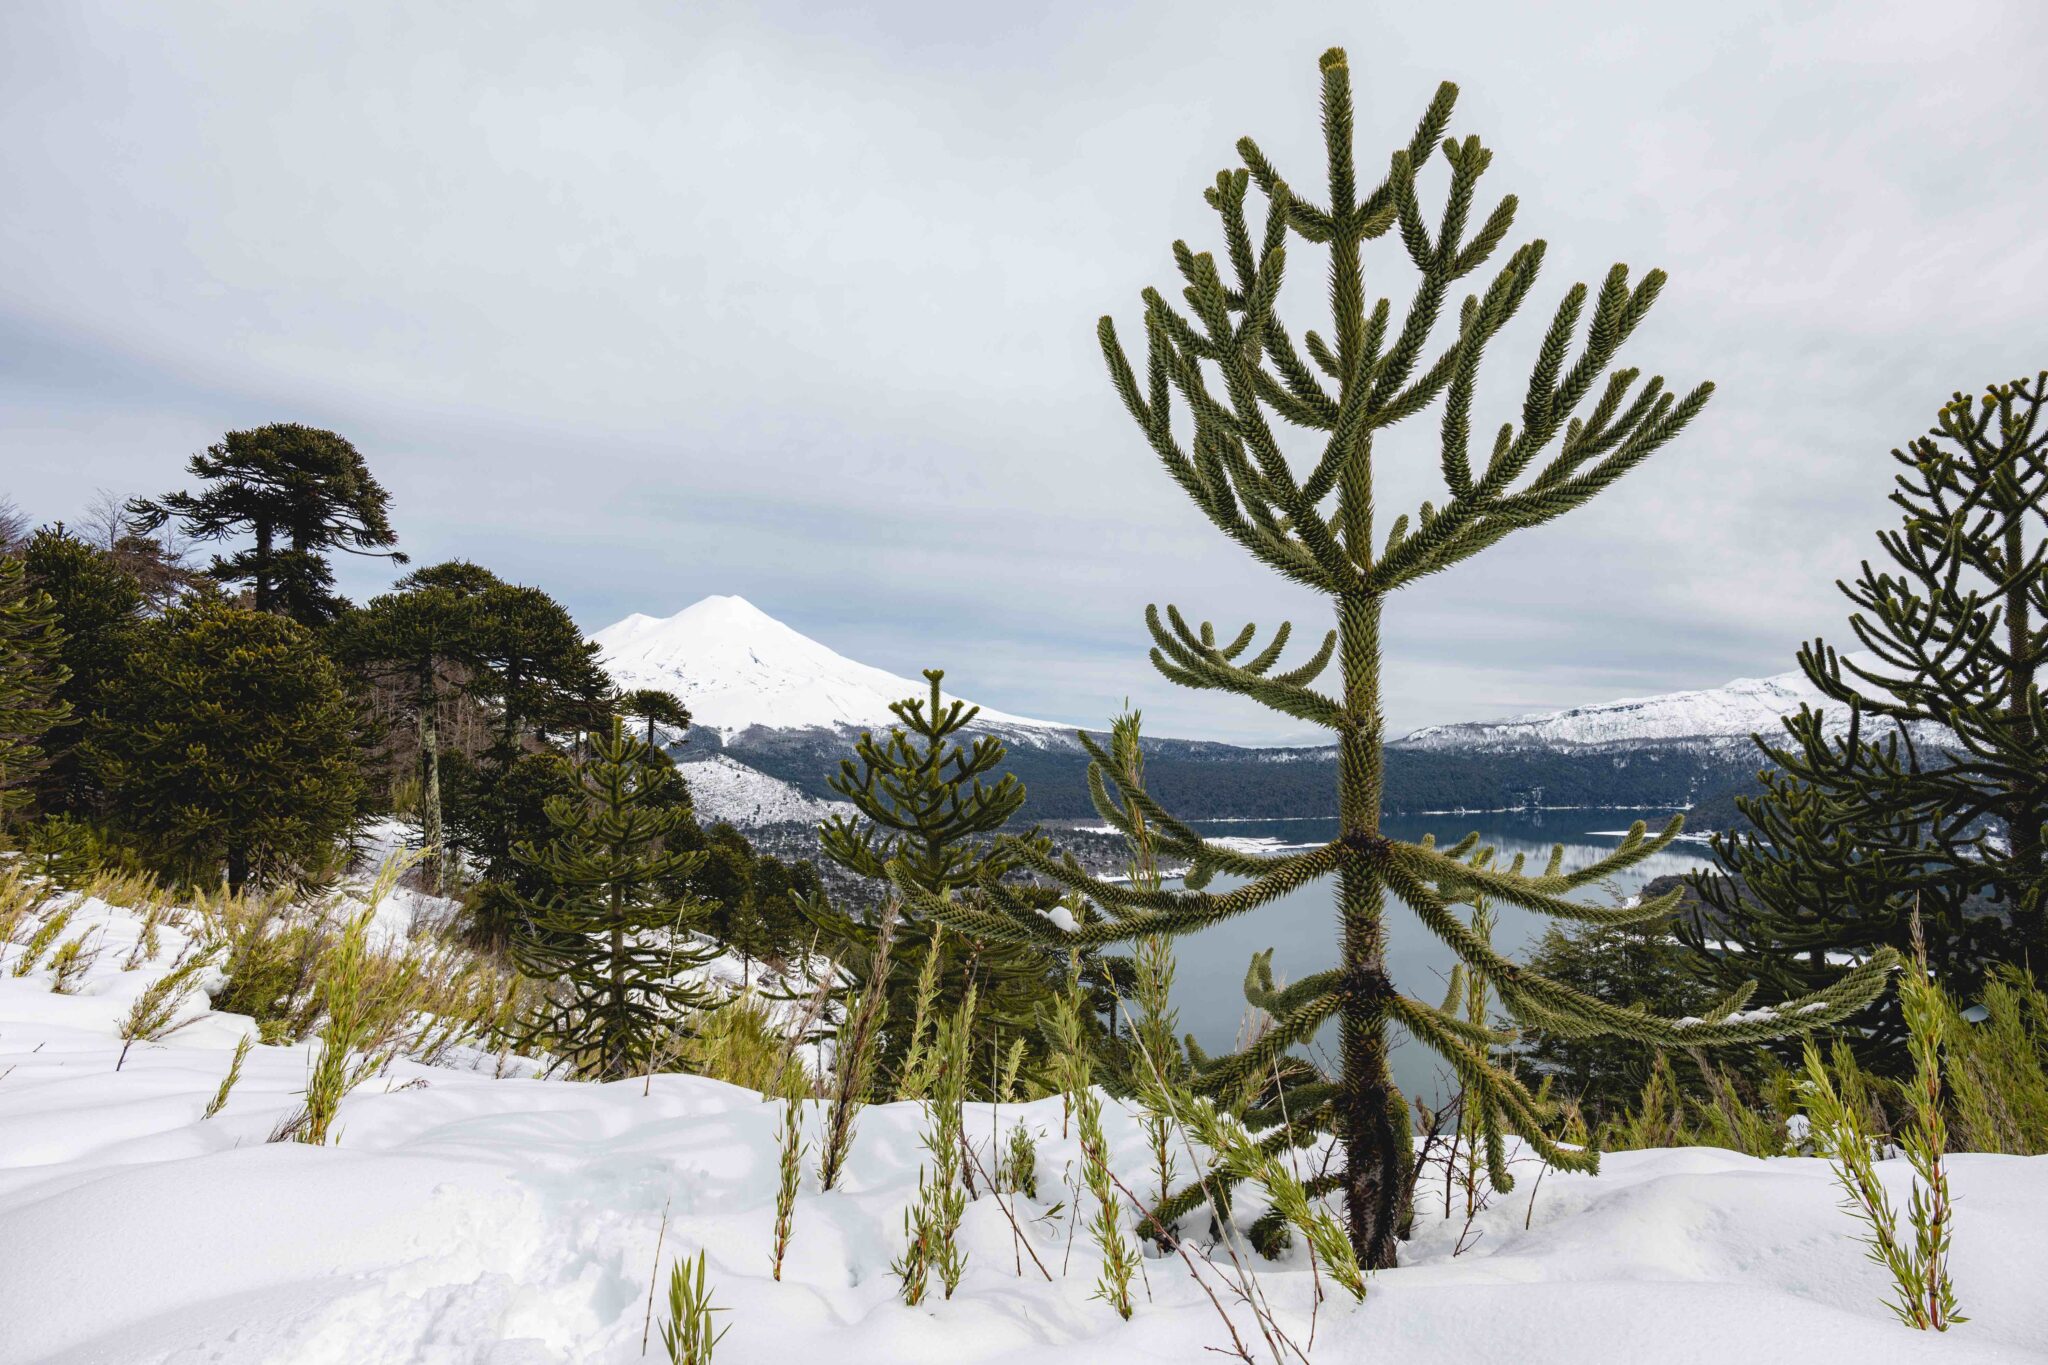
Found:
[1337,593,1413,1269]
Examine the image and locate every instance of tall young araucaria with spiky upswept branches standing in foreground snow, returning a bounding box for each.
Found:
[899,49,1892,1269]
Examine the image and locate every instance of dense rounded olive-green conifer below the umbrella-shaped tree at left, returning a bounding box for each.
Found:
[86,593,360,886]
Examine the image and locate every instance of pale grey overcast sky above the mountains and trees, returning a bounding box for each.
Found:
[0,0,2048,741]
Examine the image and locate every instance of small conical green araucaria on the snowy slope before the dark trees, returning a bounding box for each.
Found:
[512,720,717,1081]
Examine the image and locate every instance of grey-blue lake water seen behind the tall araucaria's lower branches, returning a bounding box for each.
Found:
[1174,810,1710,1099]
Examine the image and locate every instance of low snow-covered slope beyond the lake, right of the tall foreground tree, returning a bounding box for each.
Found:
[1399,653,1916,749]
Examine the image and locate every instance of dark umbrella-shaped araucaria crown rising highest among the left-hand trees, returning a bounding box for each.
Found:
[129,422,406,626]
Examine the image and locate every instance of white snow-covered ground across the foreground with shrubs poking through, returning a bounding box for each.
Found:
[0,902,2048,1365]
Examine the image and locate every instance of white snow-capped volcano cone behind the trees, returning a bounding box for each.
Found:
[590,598,1073,739]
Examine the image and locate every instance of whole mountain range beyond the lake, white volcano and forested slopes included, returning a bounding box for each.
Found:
[590,596,1839,827]
